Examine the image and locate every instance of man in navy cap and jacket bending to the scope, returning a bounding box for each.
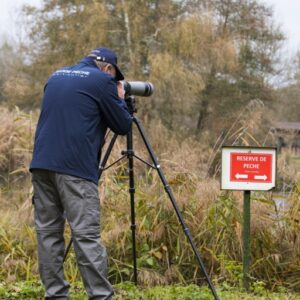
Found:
[30,48,132,300]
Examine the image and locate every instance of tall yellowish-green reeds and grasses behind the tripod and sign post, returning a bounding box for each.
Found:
[0,109,300,299]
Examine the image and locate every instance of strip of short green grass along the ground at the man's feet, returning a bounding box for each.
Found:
[0,281,300,300]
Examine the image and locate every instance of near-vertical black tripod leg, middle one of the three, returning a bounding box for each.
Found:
[126,128,137,285]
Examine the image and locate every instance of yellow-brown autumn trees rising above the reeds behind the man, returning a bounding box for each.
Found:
[2,0,298,132]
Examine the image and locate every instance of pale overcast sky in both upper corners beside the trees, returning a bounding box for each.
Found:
[0,0,300,54]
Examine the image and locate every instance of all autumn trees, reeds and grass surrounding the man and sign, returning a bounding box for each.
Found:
[0,0,300,299]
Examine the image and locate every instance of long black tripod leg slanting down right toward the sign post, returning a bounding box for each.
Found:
[133,117,219,300]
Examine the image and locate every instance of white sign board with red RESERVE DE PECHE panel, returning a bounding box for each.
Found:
[221,147,277,191]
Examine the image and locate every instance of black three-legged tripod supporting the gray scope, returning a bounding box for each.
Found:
[63,96,219,300]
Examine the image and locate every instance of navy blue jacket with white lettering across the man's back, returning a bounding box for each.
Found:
[30,58,132,184]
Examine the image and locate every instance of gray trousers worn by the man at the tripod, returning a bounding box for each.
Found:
[32,169,113,300]
